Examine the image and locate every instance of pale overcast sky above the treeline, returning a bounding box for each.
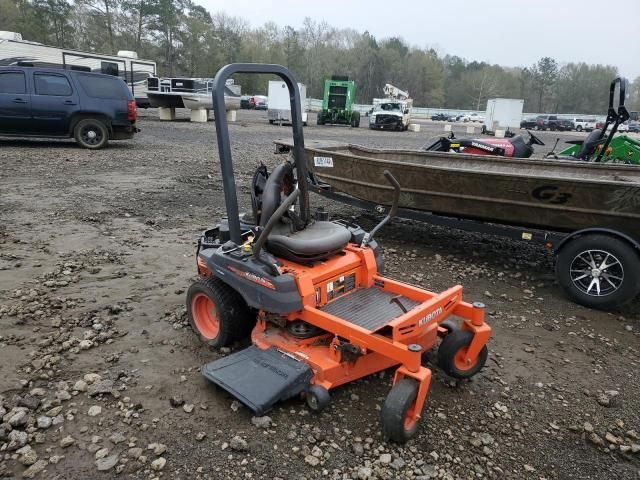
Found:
[195,0,640,80]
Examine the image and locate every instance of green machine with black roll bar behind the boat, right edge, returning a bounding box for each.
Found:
[549,78,640,165]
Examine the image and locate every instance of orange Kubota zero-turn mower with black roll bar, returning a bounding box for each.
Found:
[187,64,491,442]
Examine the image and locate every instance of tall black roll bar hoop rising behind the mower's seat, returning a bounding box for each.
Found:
[211,63,309,245]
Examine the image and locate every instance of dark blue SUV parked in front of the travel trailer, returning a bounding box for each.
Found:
[0,67,139,149]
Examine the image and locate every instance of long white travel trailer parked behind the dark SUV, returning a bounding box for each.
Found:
[0,31,156,107]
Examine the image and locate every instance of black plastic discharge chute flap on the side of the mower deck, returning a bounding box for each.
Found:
[202,346,313,415]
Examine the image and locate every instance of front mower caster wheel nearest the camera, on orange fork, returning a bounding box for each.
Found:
[381,378,421,443]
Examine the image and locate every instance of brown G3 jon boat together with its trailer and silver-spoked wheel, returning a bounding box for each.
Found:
[276,141,640,309]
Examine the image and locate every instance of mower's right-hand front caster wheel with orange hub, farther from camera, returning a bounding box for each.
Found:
[438,330,489,380]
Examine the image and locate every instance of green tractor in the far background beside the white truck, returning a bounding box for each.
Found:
[318,75,360,127]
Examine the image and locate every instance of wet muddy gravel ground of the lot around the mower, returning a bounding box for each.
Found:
[0,110,640,480]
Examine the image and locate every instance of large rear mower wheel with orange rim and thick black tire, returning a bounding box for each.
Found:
[187,278,256,348]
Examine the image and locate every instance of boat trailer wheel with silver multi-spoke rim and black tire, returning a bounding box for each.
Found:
[556,234,640,310]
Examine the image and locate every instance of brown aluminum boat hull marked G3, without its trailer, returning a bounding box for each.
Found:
[298,142,640,238]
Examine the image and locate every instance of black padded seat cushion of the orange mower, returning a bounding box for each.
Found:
[267,222,351,262]
